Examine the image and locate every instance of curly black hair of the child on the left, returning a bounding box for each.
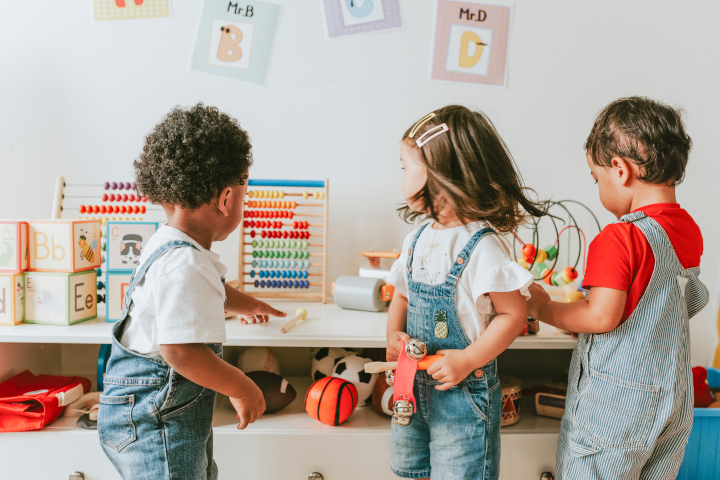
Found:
[134,102,253,210]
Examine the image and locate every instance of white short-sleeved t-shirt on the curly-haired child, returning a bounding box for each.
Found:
[120,225,227,356]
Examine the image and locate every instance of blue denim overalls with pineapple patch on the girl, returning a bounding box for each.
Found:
[390,225,502,480]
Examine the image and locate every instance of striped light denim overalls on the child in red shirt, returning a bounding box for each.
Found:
[556,212,708,480]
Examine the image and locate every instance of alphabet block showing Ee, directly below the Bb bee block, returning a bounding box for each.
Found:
[23,270,97,325]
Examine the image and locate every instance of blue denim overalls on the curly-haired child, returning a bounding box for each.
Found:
[98,241,222,480]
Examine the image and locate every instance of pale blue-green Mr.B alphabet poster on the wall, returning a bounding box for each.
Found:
[190,0,281,85]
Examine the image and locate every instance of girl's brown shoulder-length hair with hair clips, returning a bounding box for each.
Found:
[398,105,547,233]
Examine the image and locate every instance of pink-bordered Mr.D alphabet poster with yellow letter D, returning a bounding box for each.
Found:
[430,0,513,87]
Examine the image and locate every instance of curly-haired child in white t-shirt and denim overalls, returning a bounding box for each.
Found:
[98,103,285,480]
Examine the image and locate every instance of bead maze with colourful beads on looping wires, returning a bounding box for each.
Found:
[513,200,602,286]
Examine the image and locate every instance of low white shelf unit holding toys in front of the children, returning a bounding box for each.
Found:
[0,301,576,480]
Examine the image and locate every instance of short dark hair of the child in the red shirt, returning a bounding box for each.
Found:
[585,97,692,186]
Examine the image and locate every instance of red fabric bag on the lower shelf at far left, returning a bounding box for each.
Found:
[0,370,90,432]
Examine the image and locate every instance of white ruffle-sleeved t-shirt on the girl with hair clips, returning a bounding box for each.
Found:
[386,222,533,342]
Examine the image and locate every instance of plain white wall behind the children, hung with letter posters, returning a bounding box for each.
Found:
[0,0,720,363]
